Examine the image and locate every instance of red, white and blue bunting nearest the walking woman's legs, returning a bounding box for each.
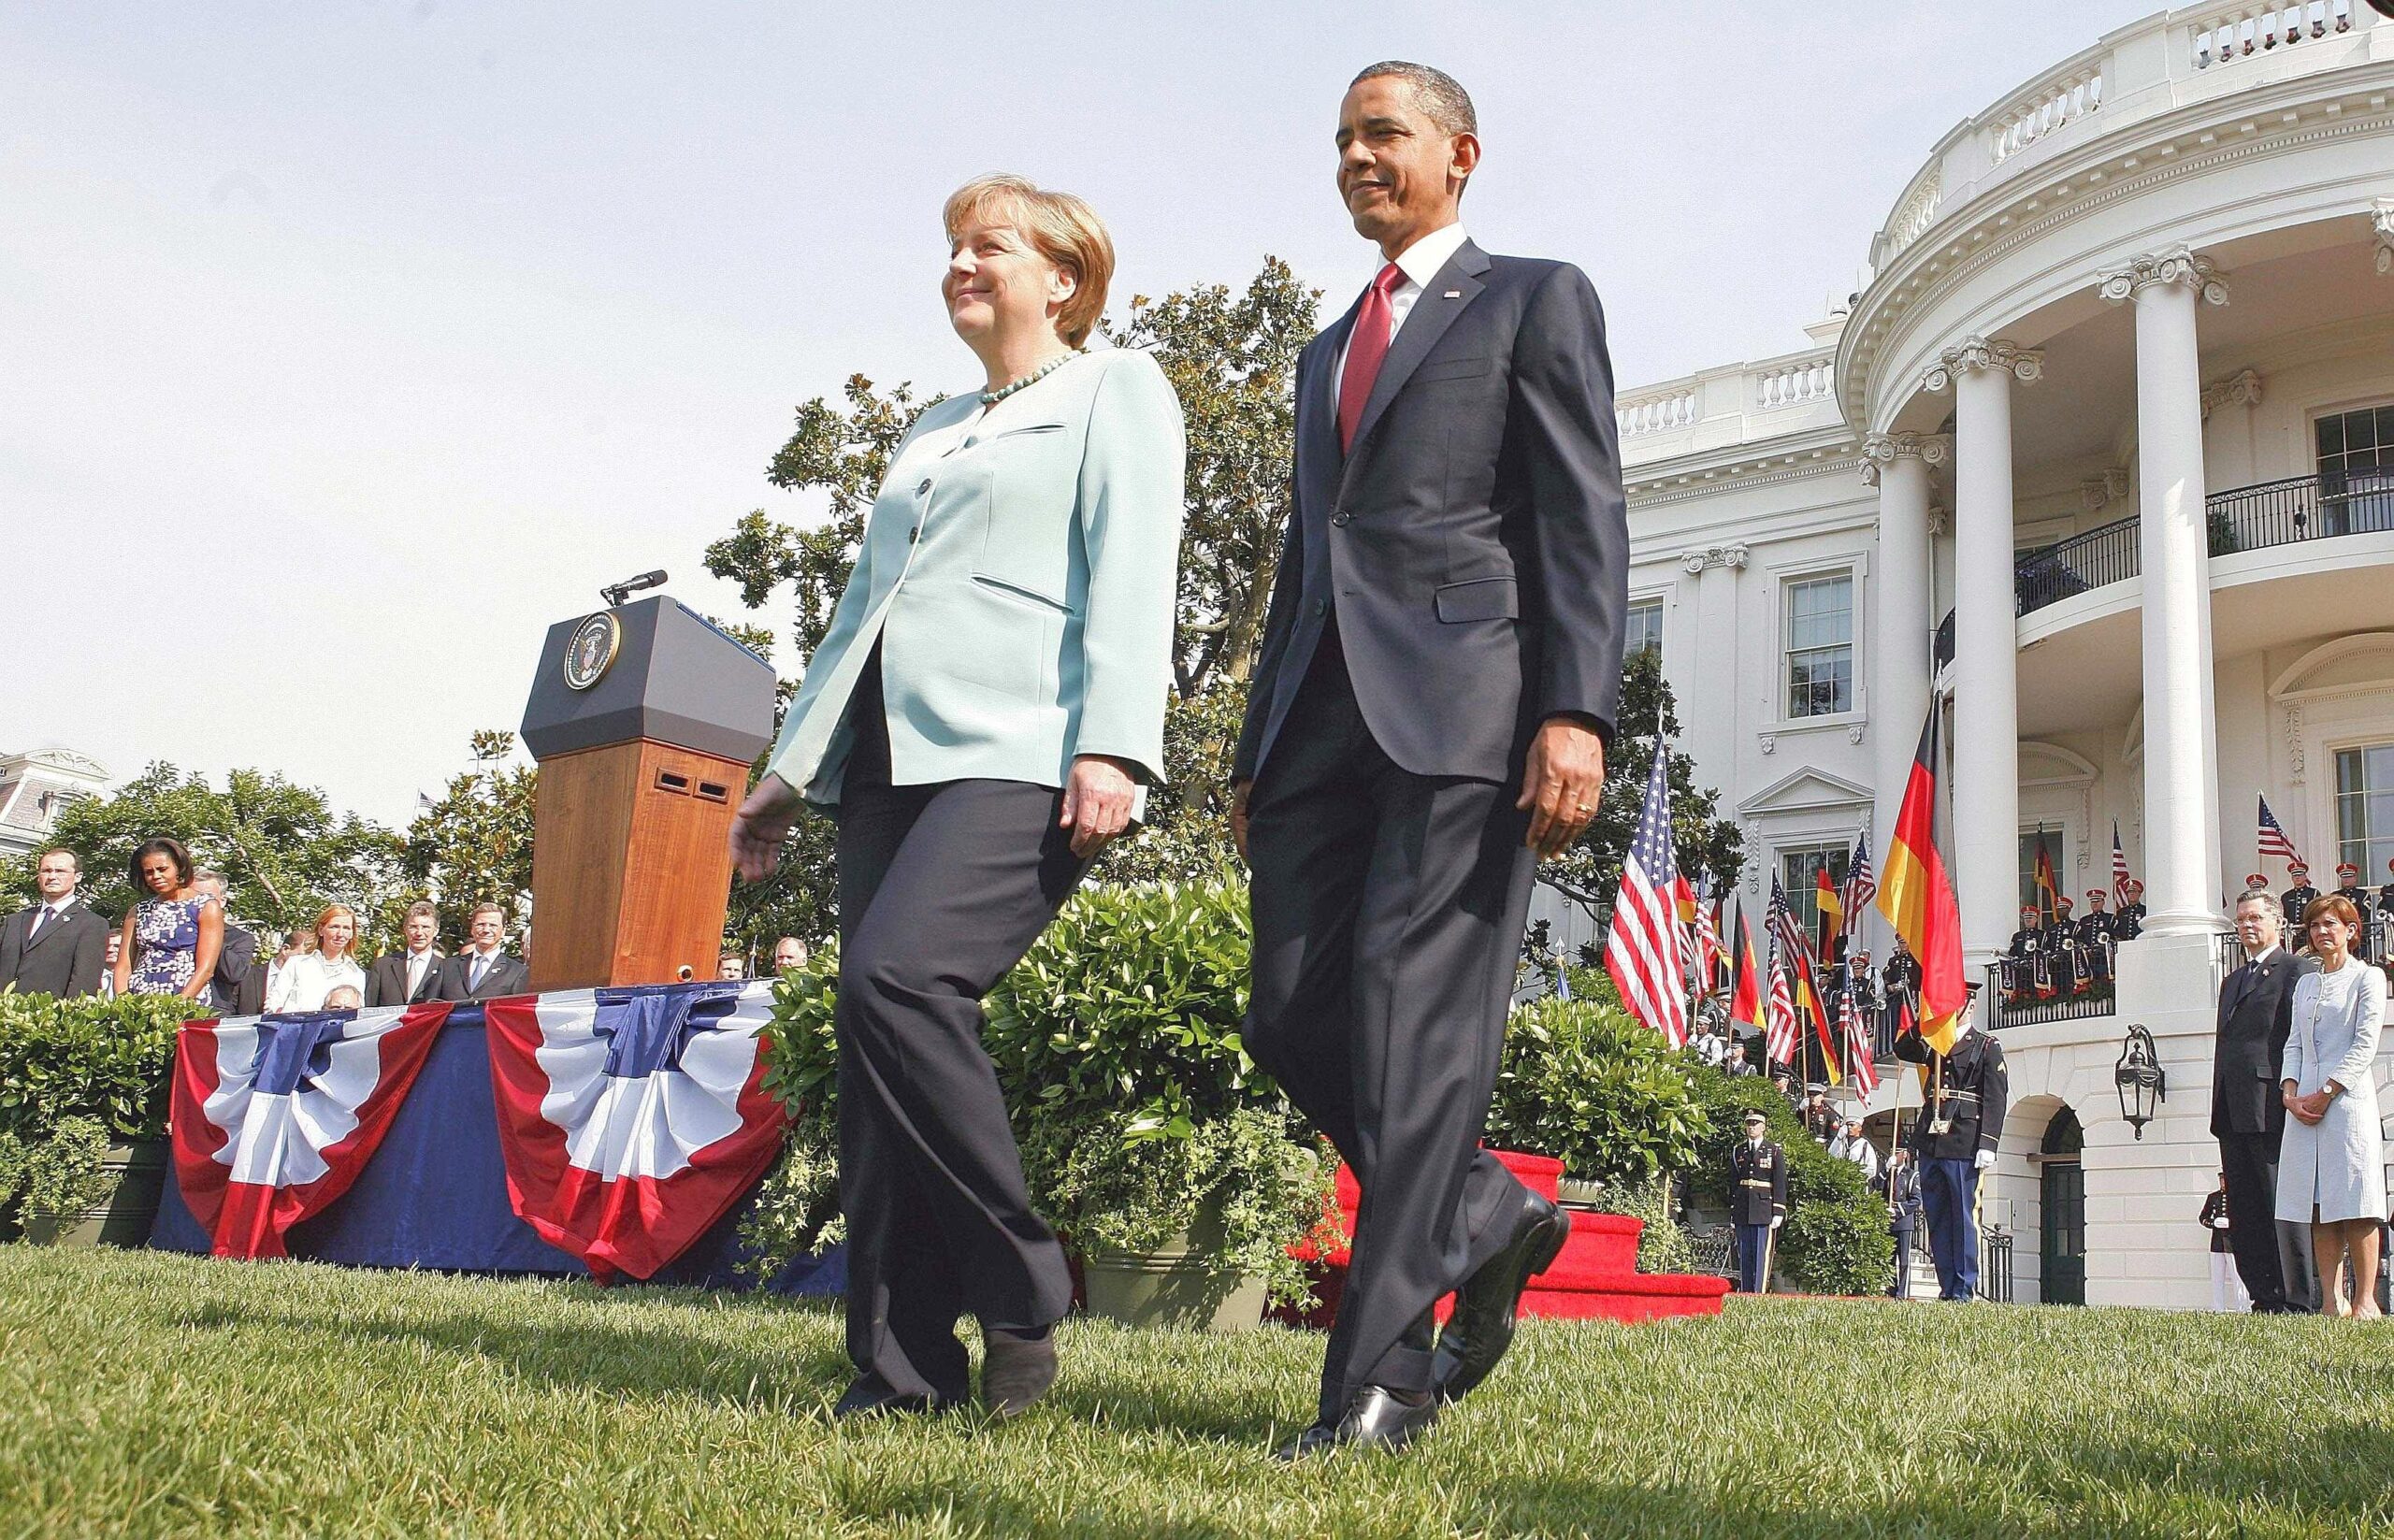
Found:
[486,980,786,1281]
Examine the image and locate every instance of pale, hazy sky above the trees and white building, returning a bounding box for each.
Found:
[0,0,2157,824]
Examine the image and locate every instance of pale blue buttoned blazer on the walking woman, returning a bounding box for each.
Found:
[766,350,1188,812]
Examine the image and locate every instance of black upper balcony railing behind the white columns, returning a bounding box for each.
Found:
[2013,467,2394,615]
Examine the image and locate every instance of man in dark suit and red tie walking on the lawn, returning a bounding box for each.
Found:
[1231,63,1628,1456]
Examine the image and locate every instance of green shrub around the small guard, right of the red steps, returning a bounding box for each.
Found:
[1690,1063,1896,1293]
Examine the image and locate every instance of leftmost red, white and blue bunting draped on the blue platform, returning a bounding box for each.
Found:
[172,1003,450,1258]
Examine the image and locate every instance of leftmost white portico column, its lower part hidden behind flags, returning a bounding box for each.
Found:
[1863,434,1954,860]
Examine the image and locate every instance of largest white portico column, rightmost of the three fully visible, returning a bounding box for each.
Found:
[2099,247,2228,939]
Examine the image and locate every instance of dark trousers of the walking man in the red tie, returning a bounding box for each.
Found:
[1245,632,1535,1418]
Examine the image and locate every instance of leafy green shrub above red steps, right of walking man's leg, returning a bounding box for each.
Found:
[1487,994,1705,1183]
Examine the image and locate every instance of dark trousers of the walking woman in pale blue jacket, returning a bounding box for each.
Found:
[838,675,1087,1401]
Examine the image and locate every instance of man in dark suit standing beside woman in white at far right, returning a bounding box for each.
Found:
[2212,888,2315,1315]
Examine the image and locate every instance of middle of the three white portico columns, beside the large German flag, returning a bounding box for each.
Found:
[1923,338,2044,975]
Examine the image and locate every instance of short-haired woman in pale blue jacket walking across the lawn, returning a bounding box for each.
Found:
[732,178,1185,1416]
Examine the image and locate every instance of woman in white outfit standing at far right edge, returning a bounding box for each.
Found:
[2277,893,2387,1317]
